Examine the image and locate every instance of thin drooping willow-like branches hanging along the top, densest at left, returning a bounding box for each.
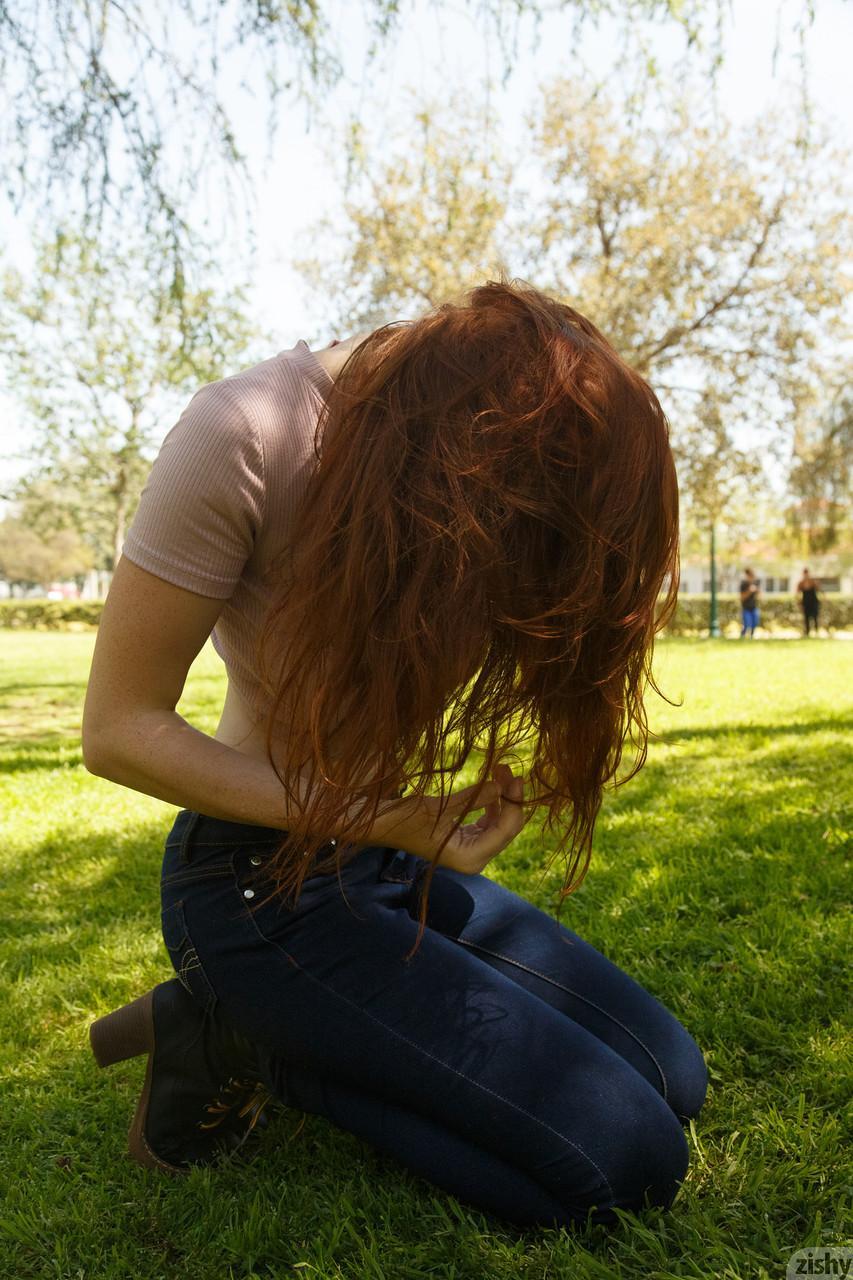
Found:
[0,0,742,279]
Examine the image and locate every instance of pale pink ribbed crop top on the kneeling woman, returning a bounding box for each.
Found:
[123,338,333,718]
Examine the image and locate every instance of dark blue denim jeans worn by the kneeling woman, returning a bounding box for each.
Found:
[161,809,707,1226]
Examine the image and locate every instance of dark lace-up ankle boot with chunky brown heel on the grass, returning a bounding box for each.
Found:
[88,978,272,1174]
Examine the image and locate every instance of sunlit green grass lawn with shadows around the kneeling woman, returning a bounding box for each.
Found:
[0,632,853,1280]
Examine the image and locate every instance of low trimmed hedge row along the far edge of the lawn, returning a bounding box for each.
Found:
[0,595,853,636]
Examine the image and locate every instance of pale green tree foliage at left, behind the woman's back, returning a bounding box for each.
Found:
[0,229,257,570]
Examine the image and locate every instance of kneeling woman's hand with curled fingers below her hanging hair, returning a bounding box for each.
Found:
[369,764,529,876]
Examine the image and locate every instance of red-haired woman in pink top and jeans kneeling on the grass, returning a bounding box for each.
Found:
[83,279,706,1225]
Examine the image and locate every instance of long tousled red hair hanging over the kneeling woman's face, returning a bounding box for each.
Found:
[257,276,679,927]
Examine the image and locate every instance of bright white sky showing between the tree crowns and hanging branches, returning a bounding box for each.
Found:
[0,0,853,499]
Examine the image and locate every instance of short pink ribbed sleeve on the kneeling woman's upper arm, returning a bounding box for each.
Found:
[122,381,264,599]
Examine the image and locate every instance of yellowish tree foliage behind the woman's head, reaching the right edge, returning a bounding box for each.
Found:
[313,77,853,460]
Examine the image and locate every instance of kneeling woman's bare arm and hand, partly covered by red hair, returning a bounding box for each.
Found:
[82,557,526,873]
